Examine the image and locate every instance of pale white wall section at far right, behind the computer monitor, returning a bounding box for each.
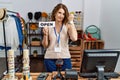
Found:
[100,0,120,72]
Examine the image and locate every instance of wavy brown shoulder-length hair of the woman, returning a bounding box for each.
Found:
[51,3,69,24]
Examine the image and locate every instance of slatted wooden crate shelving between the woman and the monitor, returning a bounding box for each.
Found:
[69,29,83,71]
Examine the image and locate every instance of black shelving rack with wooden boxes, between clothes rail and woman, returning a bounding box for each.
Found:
[27,22,44,55]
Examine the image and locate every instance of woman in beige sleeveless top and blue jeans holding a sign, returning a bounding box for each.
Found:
[42,3,77,72]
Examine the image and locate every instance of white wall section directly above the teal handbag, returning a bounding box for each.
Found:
[83,0,101,30]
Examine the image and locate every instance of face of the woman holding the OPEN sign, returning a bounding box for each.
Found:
[55,8,65,22]
